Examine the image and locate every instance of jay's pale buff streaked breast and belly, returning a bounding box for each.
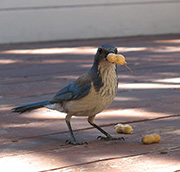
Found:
[63,61,117,116]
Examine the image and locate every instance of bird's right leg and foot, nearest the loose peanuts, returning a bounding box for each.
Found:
[88,116,125,140]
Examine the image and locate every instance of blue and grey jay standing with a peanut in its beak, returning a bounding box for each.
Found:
[12,44,124,145]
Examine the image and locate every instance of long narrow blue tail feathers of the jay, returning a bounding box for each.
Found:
[12,100,49,113]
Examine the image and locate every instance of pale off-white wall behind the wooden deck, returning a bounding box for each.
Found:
[0,0,180,43]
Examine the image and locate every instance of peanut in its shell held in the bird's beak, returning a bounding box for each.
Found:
[107,53,126,65]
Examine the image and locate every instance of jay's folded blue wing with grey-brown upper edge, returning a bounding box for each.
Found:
[50,74,91,103]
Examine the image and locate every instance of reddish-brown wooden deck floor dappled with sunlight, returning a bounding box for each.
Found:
[0,35,180,172]
